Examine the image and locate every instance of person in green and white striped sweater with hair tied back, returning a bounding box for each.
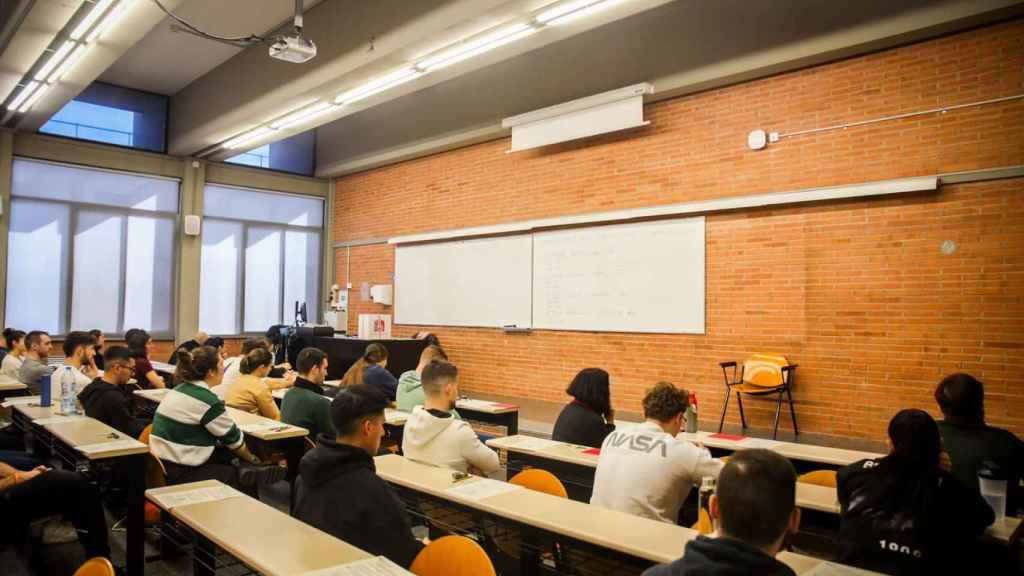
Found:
[150,346,286,492]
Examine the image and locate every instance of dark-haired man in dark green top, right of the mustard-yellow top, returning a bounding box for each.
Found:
[281,347,335,439]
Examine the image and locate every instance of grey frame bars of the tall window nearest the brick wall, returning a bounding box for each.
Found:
[197,183,328,338]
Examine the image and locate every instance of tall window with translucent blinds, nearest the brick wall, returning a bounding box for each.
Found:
[199,184,324,335]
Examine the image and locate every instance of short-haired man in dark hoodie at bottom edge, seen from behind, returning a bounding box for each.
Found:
[643,449,800,576]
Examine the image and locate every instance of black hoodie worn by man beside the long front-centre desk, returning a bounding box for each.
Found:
[294,436,423,568]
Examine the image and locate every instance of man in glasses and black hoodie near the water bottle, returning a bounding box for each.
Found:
[78,346,145,438]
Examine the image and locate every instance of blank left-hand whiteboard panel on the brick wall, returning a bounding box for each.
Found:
[394,234,532,327]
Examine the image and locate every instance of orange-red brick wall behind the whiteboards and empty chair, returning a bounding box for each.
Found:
[334,20,1024,438]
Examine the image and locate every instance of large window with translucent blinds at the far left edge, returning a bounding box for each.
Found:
[5,158,178,335]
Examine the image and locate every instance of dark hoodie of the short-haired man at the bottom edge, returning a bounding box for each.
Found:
[643,536,797,576]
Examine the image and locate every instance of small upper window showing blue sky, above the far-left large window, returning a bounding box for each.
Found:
[39,82,167,152]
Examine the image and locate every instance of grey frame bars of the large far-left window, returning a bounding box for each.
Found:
[5,154,182,340]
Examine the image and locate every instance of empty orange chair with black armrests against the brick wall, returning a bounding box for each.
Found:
[718,354,800,439]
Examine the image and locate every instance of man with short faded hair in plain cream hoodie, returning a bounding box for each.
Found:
[401,360,500,475]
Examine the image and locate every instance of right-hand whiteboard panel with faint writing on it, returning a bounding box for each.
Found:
[532,216,705,334]
